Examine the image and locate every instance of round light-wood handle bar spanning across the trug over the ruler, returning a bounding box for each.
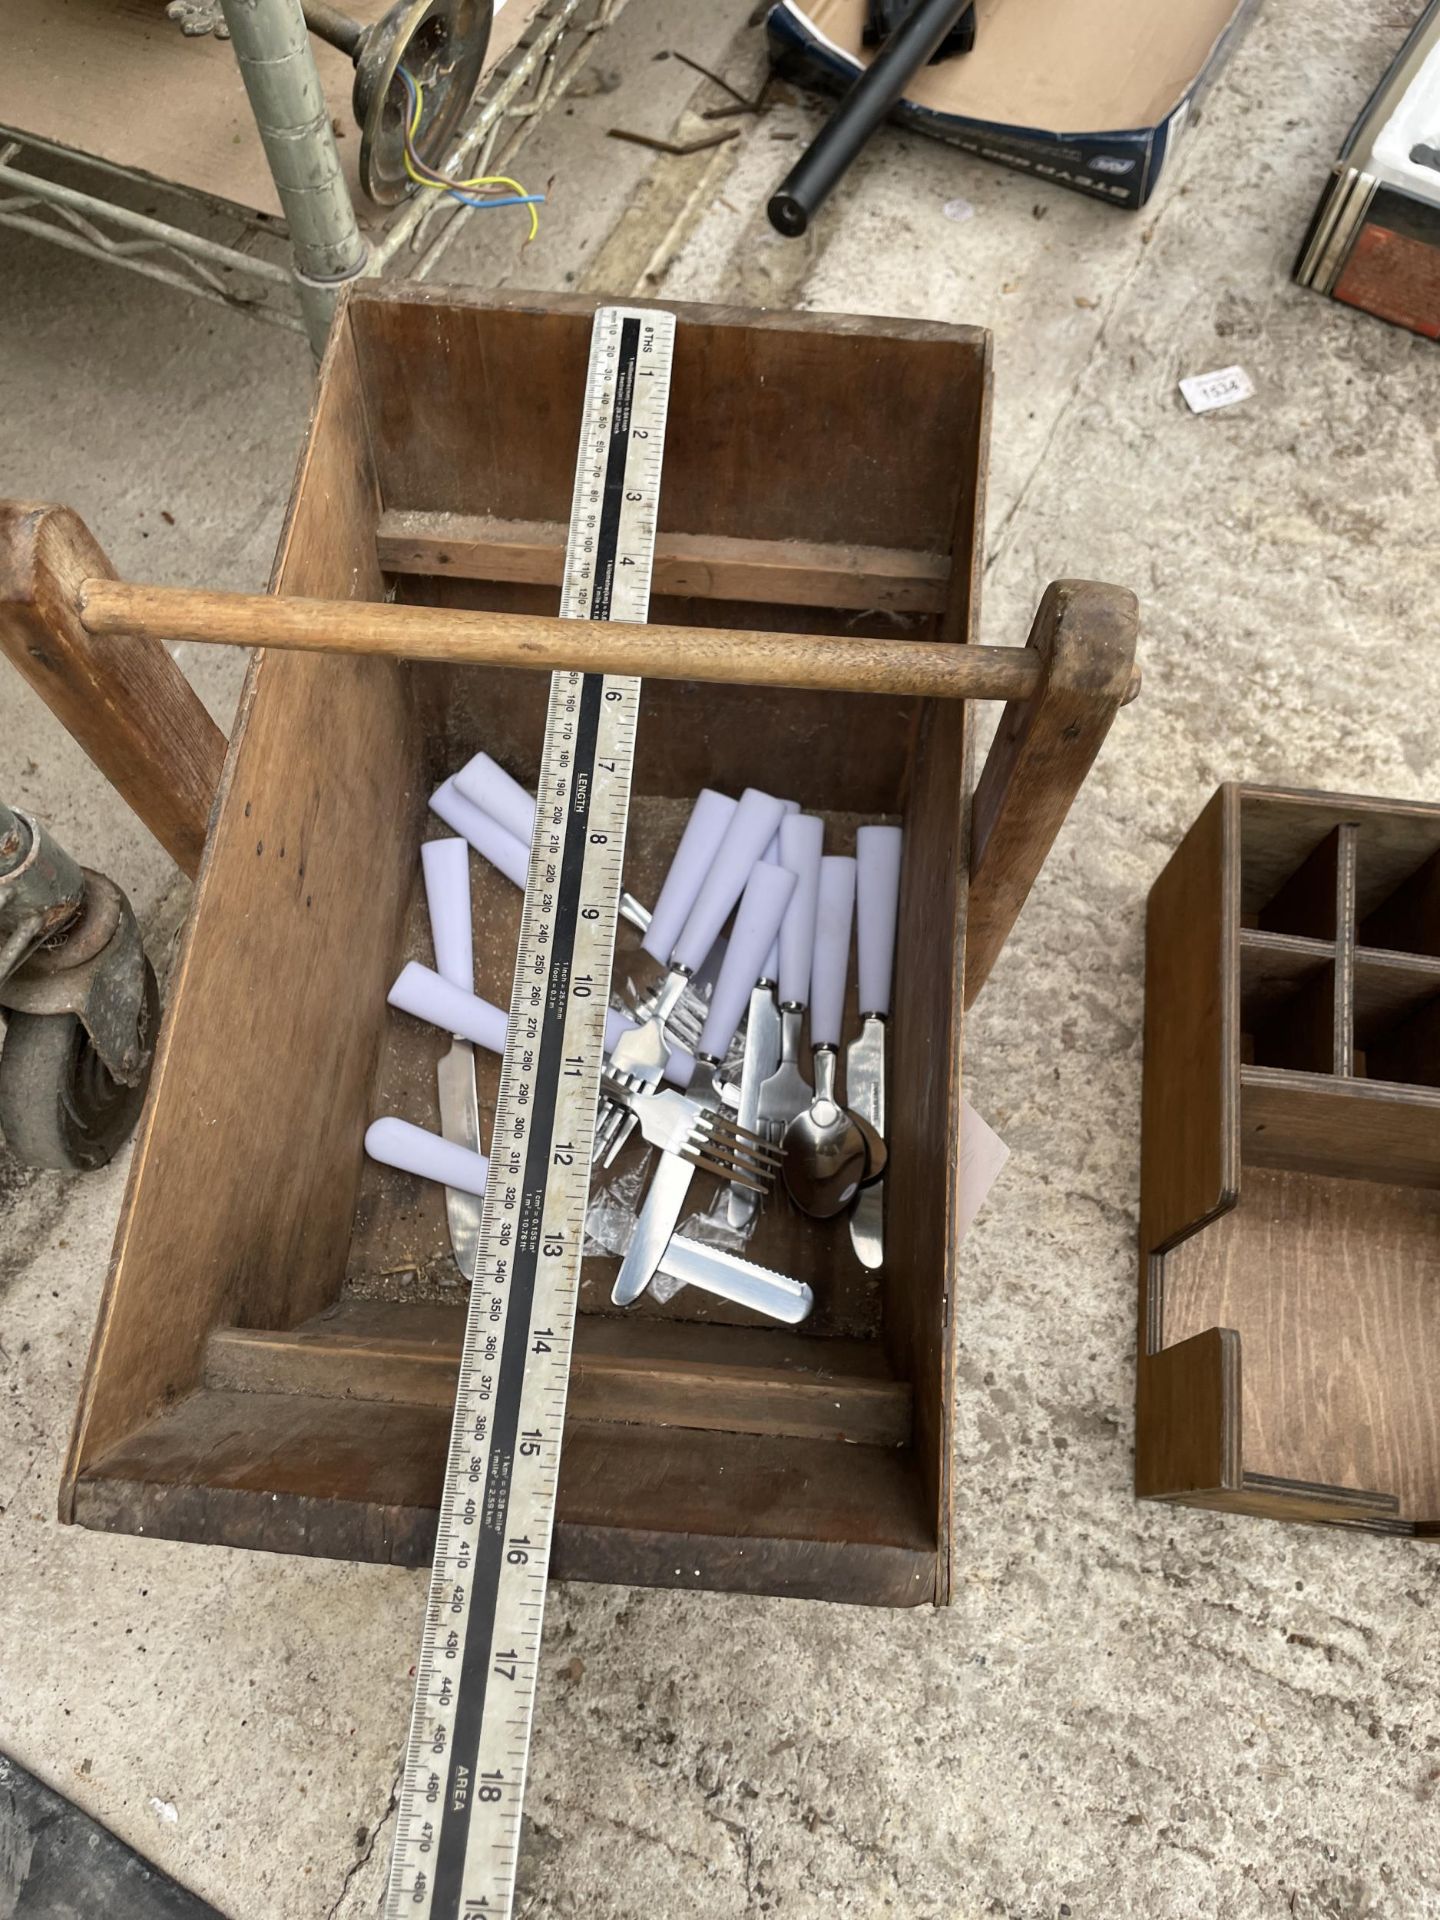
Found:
[79,580,1043,701]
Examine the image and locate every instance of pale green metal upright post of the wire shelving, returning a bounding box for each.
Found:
[221,0,367,353]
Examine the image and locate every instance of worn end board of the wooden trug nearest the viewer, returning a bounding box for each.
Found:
[75,1390,935,1607]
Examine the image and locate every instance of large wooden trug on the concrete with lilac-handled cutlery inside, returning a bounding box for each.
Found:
[42,288,1135,1605]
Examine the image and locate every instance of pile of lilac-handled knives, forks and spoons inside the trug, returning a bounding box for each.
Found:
[365,753,902,1325]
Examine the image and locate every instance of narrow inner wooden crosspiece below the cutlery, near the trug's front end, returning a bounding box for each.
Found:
[205,1308,910,1446]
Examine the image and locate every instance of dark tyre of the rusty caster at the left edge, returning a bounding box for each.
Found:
[0,960,159,1173]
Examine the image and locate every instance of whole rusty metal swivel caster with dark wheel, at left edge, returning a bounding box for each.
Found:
[0,803,159,1173]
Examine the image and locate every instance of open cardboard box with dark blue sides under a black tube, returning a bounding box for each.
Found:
[766,0,1250,207]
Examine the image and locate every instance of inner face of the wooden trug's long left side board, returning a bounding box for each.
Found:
[61,314,403,1517]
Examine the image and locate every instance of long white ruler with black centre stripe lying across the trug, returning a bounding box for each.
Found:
[384,307,676,1920]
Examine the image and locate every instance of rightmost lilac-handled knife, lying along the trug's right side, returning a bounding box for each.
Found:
[845,828,904,1269]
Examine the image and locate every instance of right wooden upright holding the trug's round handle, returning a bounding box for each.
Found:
[966,580,1140,1006]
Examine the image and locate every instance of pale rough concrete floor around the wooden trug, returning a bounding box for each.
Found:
[0,0,1440,1920]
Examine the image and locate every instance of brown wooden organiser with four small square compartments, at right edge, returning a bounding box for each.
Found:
[1135,785,1440,1534]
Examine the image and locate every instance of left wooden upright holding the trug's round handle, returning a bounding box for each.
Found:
[0,501,225,879]
